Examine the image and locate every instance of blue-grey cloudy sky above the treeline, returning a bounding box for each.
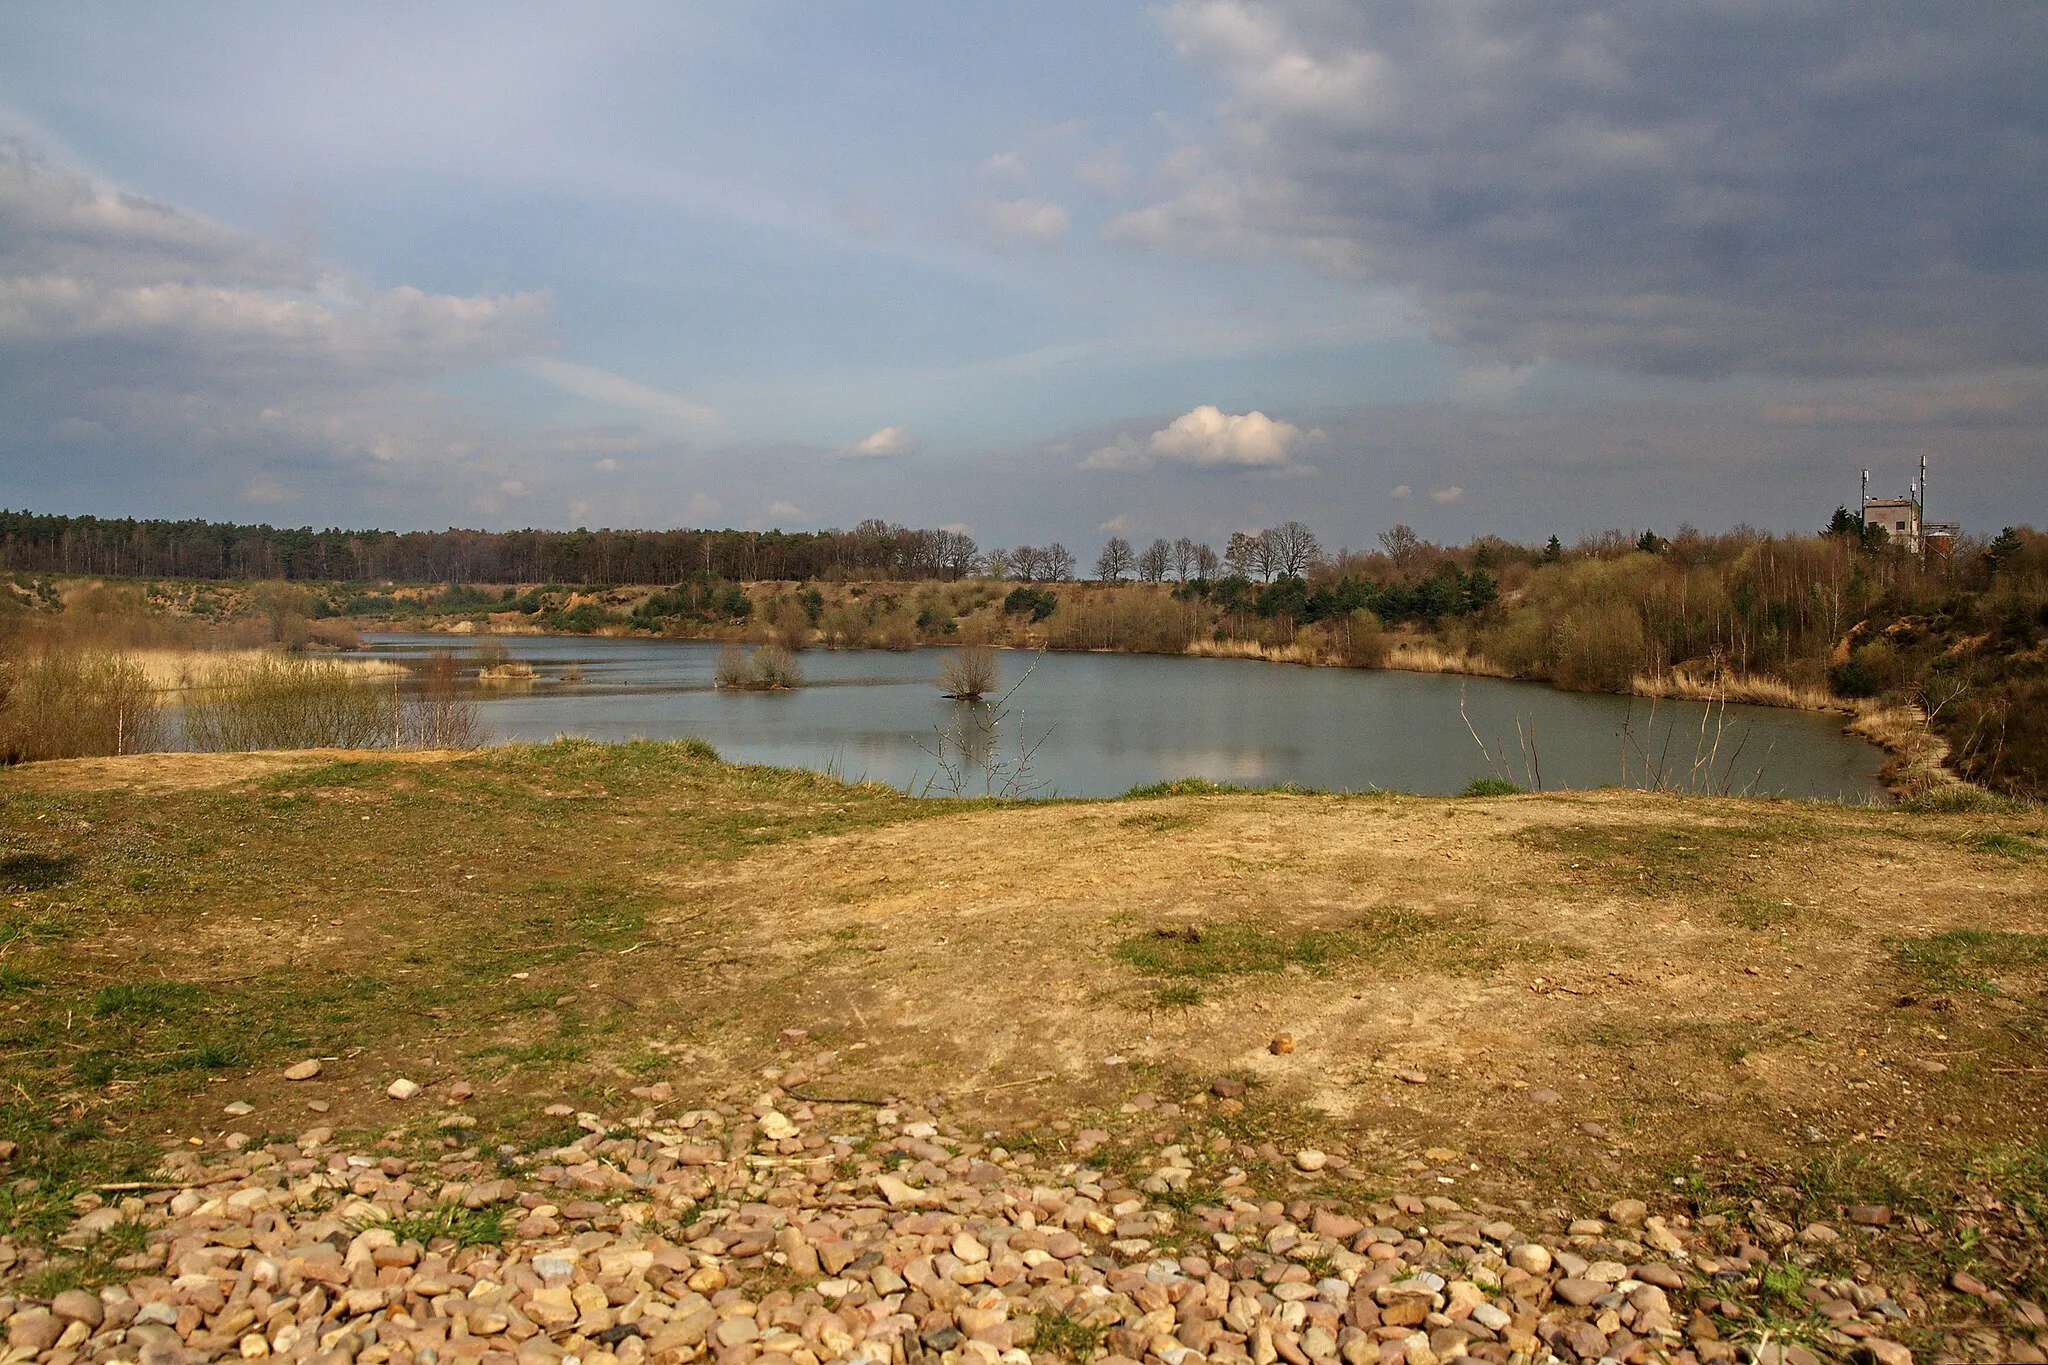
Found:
[0,0,2048,553]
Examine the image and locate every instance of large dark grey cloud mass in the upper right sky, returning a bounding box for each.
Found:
[1108,0,2048,377]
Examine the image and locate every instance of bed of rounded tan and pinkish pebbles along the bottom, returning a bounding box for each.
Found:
[4,1083,2015,1365]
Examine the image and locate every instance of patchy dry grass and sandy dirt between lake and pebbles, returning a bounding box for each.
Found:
[0,743,2048,1297]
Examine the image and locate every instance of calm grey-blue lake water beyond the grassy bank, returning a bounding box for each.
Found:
[369,634,1884,800]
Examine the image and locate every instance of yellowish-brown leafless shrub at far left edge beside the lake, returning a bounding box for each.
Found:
[0,649,164,761]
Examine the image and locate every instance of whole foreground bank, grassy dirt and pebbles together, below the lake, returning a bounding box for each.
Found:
[0,743,2048,1365]
